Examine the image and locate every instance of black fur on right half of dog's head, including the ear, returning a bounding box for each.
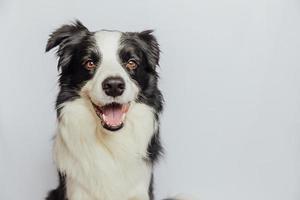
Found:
[119,30,163,113]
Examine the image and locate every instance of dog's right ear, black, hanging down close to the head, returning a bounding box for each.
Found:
[138,30,160,69]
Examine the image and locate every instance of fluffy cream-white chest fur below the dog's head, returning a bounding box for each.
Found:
[54,98,156,200]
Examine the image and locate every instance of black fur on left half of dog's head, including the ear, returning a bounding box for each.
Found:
[46,21,101,116]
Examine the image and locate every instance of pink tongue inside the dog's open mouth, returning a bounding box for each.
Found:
[102,105,123,126]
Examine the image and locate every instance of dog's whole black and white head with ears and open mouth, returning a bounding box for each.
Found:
[46,21,162,131]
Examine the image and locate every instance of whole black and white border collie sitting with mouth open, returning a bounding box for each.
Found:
[46,21,163,200]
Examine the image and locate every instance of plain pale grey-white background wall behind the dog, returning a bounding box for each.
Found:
[0,0,300,200]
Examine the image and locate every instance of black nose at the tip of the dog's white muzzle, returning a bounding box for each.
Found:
[102,77,125,97]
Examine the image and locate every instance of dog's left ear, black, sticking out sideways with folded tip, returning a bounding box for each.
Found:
[46,20,88,52]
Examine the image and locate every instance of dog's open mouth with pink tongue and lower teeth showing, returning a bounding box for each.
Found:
[92,102,129,131]
